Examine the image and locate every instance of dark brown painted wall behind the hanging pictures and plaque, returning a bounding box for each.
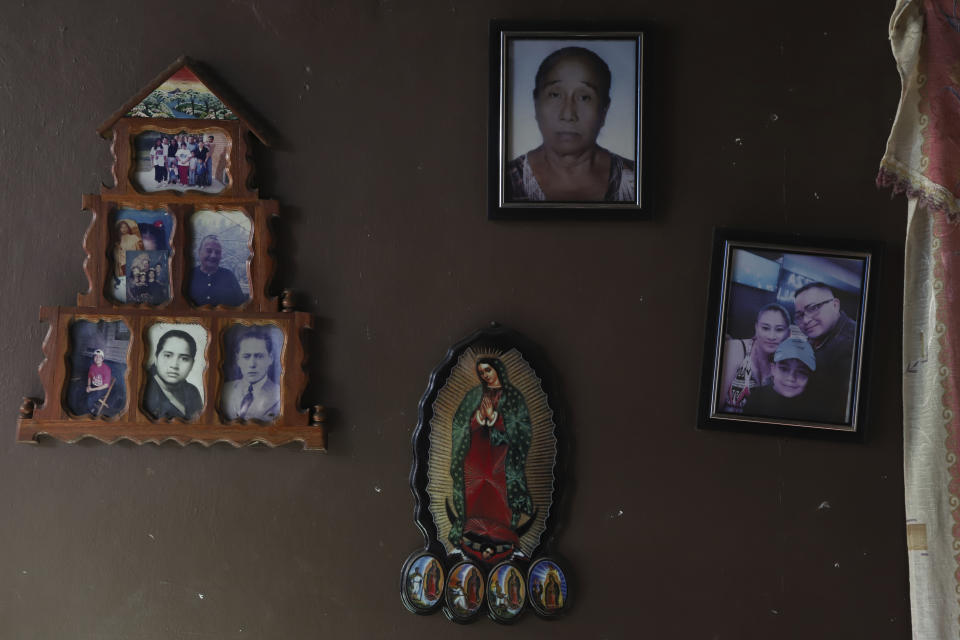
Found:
[0,0,910,640]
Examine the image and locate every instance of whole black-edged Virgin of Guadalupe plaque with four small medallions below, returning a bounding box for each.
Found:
[401,325,566,623]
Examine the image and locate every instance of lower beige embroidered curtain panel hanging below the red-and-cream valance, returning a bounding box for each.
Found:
[903,199,960,640]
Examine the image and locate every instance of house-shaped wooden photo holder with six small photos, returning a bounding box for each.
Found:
[17,57,326,450]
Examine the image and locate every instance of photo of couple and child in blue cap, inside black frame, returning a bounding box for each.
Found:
[710,236,870,430]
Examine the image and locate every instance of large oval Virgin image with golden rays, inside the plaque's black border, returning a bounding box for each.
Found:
[427,347,556,567]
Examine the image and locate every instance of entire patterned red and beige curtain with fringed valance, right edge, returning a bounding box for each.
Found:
[877,0,960,640]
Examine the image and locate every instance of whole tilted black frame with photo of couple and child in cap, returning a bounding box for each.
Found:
[700,230,879,437]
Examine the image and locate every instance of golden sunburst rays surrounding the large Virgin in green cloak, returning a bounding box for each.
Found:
[427,347,557,556]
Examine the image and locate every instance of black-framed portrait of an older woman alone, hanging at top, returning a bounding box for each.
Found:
[489,21,650,219]
